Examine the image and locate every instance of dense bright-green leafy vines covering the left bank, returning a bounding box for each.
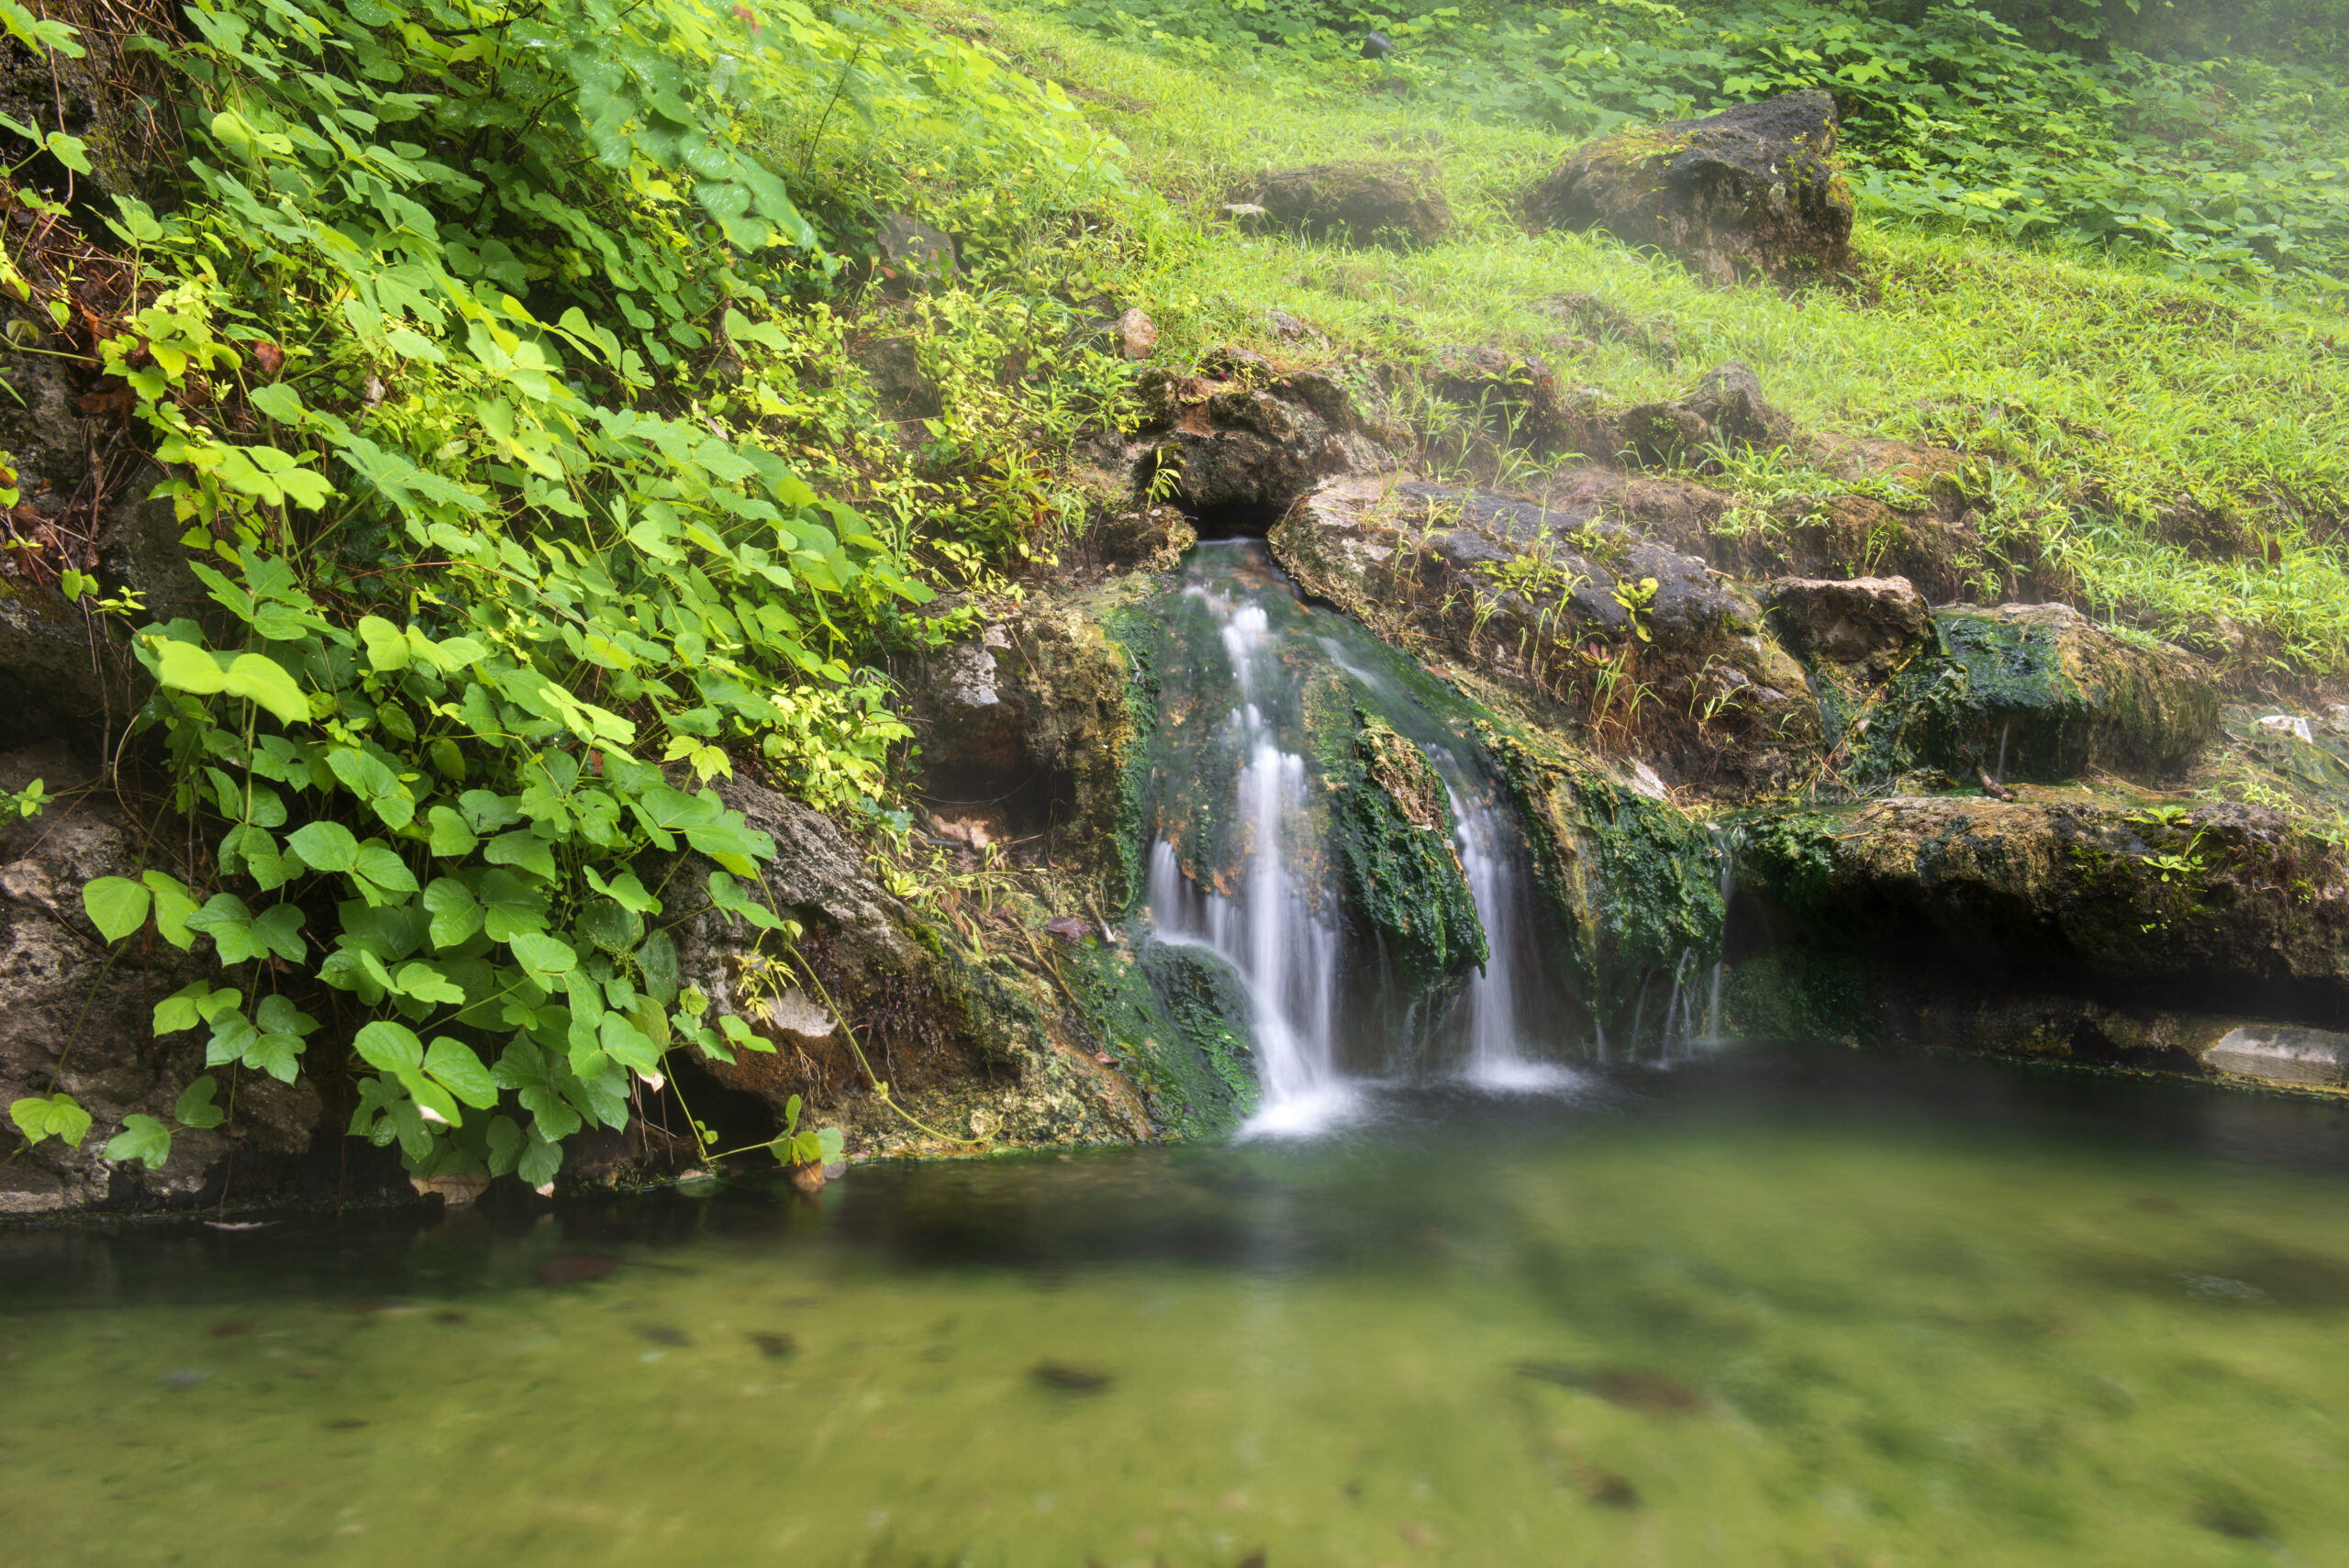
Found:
[0,0,1116,1185]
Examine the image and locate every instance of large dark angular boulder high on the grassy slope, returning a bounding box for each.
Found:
[1530,92,1854,284]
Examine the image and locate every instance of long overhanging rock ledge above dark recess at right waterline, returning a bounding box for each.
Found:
[1741,794,2349,1007]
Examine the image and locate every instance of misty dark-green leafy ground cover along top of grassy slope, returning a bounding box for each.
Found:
[1045,0,2349,277]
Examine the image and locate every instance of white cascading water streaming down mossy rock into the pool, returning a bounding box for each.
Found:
[1144,545,1576,1134]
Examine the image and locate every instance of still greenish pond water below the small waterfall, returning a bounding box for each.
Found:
[0,1047,2349,1568]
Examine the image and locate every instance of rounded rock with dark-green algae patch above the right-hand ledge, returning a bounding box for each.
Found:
[1855,604,2220,782]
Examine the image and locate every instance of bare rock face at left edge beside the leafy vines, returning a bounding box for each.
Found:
[0,744,334,1216]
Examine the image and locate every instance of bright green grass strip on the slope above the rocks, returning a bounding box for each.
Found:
[925,12,2349,681]
